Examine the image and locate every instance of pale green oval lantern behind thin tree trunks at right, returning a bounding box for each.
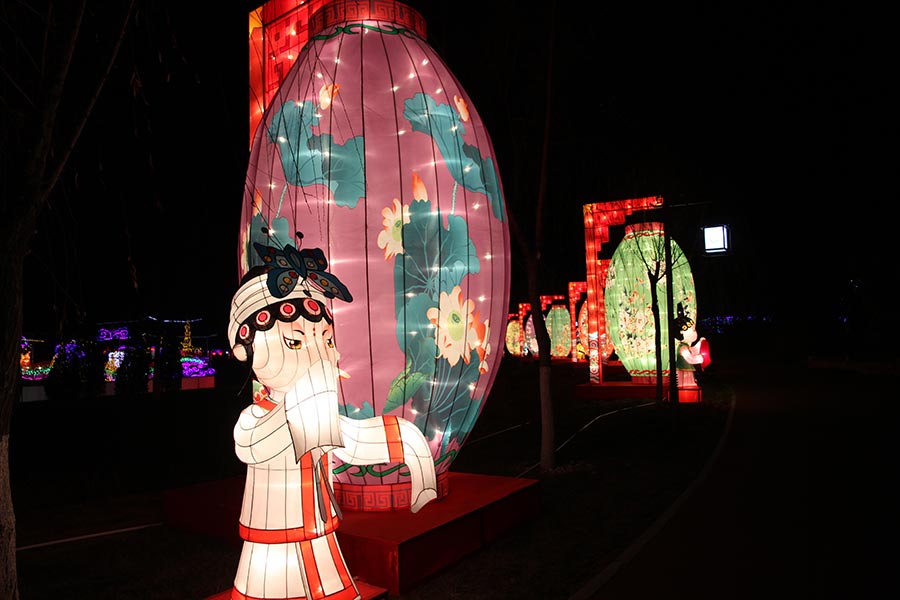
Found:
[605,222,697,380]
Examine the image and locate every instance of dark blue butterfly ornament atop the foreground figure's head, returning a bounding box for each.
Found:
[253,231,353,302]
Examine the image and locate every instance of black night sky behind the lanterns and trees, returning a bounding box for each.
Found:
[19,0,897,352]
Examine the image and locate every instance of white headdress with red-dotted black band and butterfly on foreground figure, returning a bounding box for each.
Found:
[228,232,353,352]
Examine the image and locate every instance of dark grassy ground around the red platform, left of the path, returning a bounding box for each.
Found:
[10,324,828,600]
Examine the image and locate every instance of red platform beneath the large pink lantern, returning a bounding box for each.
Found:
[165,472,540,600]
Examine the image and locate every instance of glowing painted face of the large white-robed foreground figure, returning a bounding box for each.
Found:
[253,318,340,393]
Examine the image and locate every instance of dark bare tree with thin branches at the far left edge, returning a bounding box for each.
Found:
[0,0,136,600]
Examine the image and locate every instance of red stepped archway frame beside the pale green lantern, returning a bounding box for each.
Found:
[584,196,663,383]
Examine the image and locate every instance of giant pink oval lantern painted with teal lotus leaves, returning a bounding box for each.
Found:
[239,1,510,510]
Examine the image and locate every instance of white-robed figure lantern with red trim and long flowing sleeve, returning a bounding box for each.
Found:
[228,240,437,600]
